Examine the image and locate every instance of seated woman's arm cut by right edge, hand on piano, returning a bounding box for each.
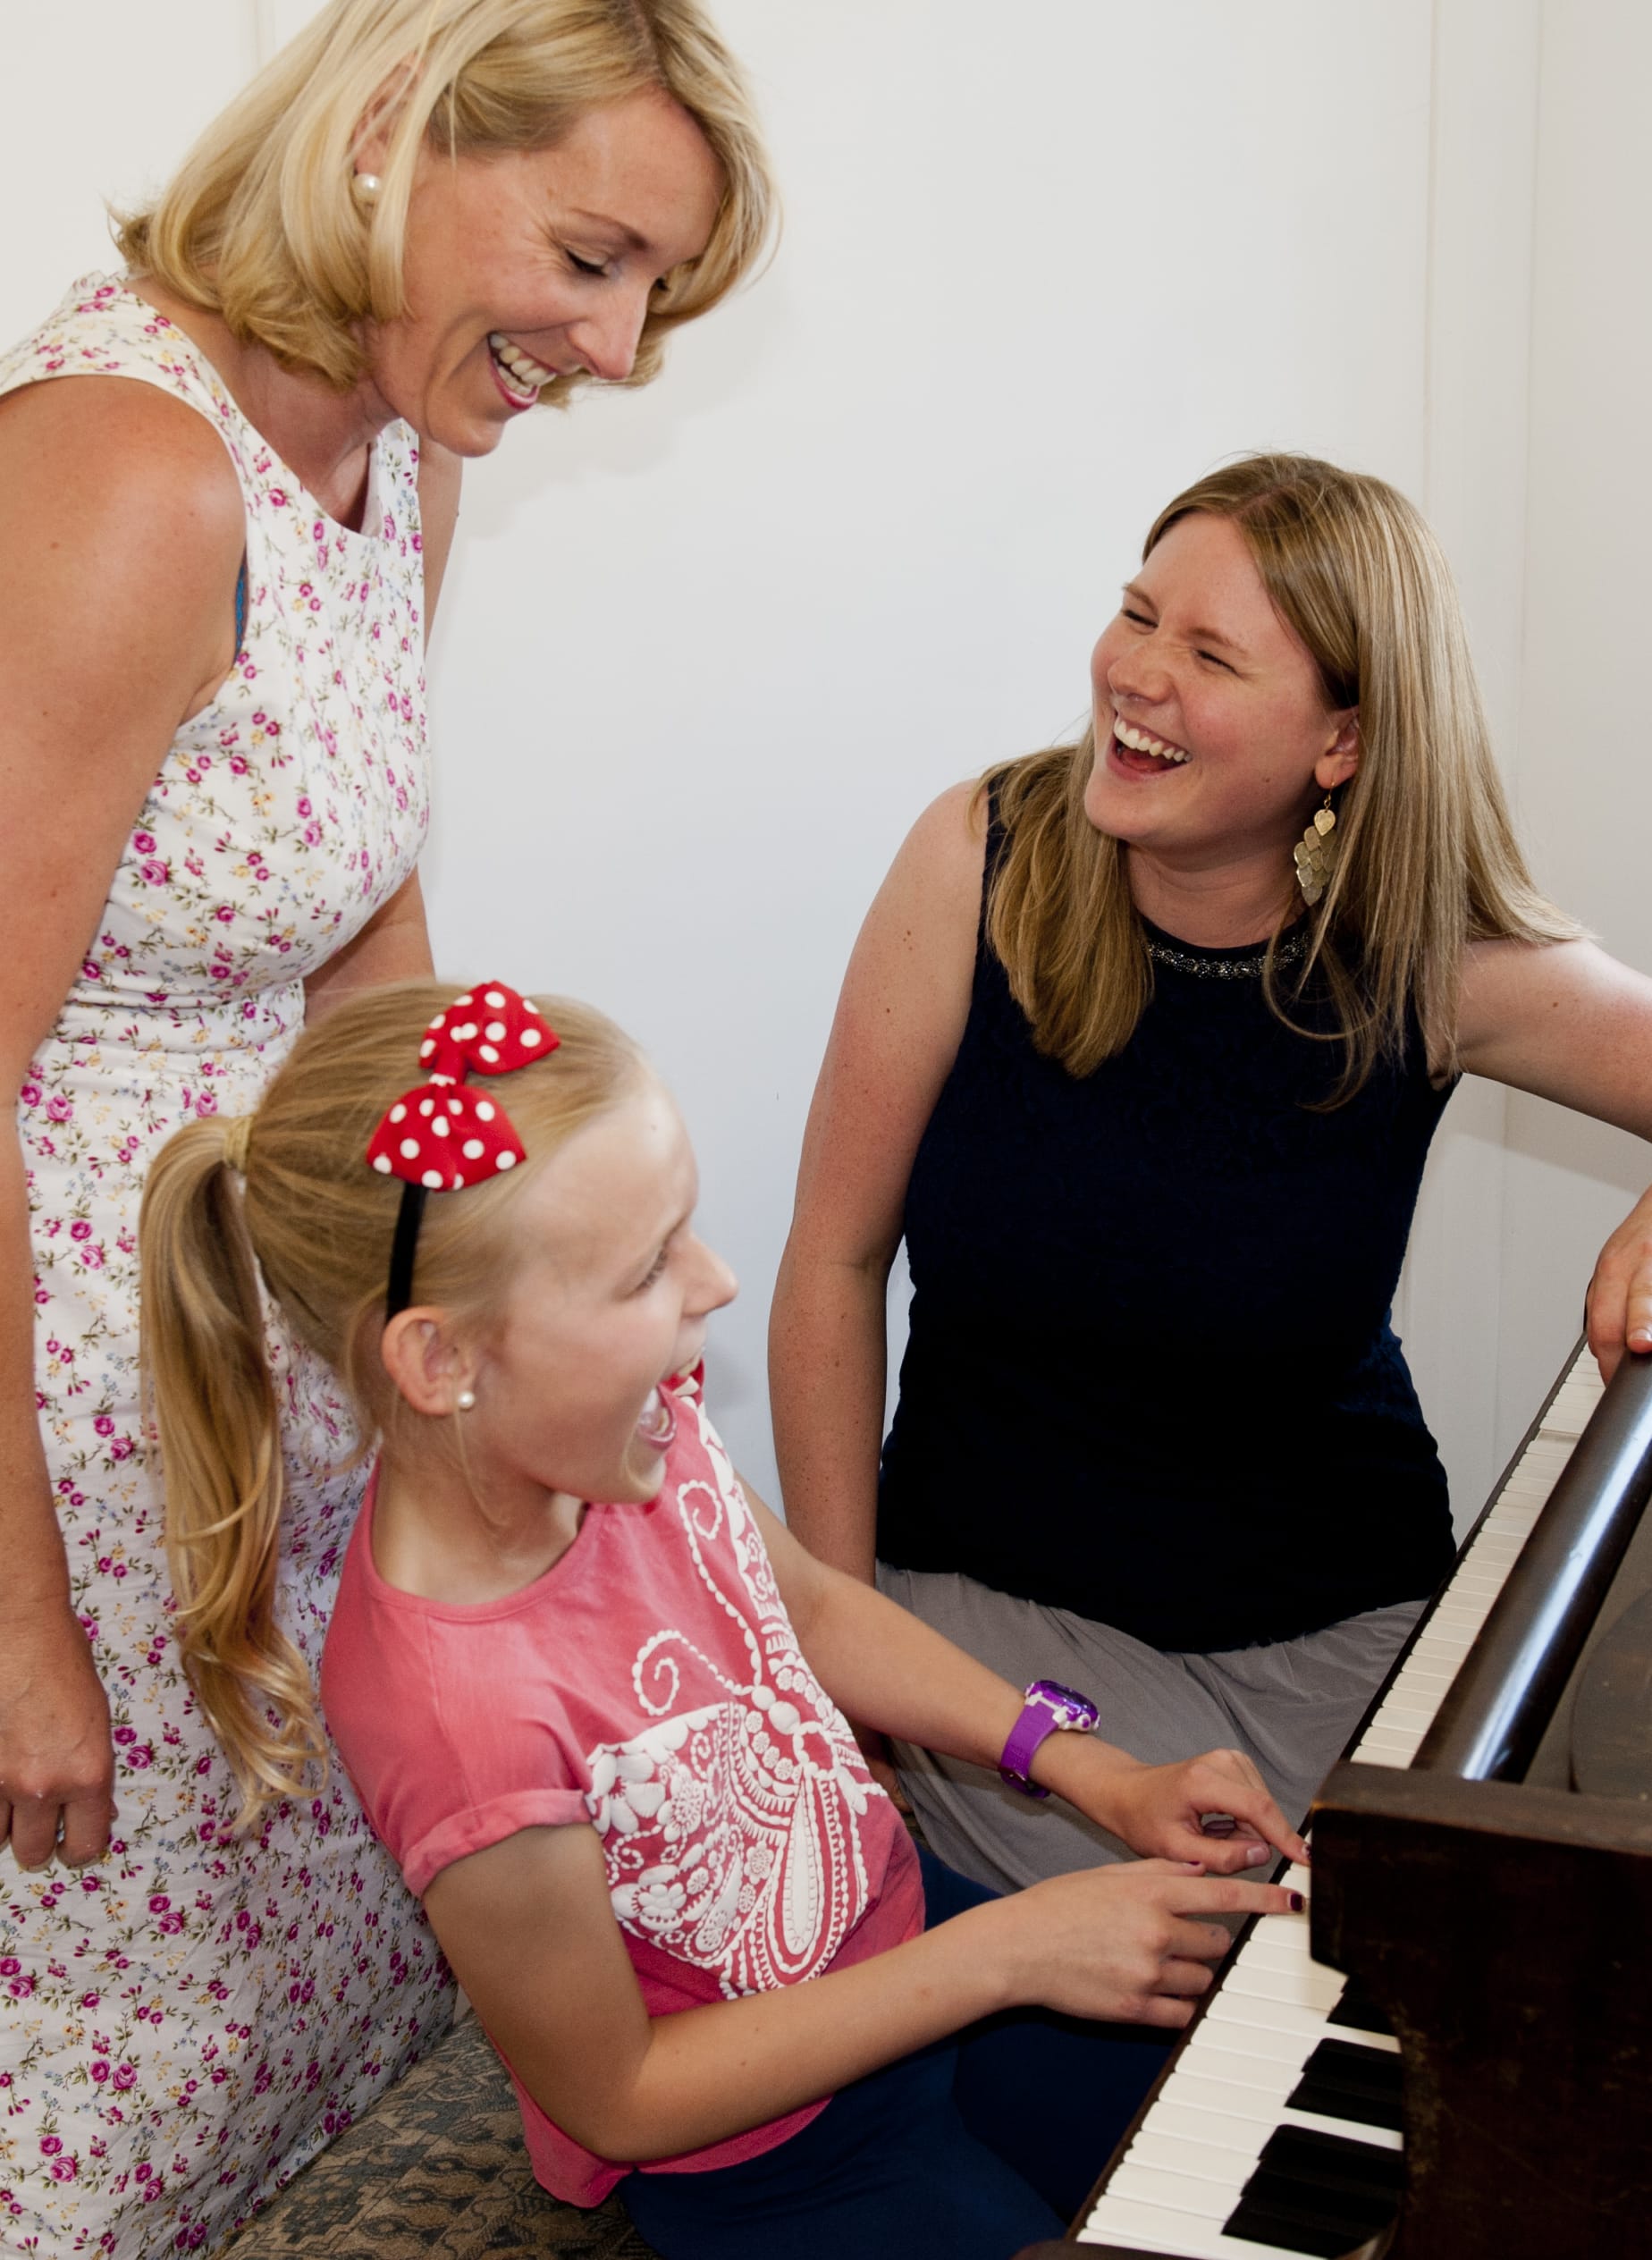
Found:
[1458,942,1652,1379]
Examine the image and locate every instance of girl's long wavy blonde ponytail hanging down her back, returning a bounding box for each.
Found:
[140,1118,328,1824]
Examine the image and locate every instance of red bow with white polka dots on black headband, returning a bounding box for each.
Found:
[367,981,560,1320]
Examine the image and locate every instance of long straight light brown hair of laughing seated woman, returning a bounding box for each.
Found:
[981,454,1582,1100]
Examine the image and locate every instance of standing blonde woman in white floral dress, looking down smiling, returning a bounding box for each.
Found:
[0,0,769,2256]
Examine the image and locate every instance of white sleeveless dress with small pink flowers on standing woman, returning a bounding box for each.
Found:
[0,275,452,2260]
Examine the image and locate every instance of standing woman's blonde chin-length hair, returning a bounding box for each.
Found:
[115,0,775,405]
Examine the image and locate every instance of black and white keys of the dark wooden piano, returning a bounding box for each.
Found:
[1078,1349,1602,2260]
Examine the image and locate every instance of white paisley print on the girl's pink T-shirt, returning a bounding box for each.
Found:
[586,1408,881,1998]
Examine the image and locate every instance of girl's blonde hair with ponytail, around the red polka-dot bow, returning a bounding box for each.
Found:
[138,981,644,1828]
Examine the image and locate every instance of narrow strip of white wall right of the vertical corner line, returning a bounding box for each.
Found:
[1498,0,1652,1433]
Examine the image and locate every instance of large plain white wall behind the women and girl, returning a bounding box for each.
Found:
[0,0,1652,1537]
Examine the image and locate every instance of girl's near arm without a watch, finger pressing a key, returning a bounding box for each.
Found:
[425,1828,1291,2161]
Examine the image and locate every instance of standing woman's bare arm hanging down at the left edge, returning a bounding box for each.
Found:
[0,377,244,1867]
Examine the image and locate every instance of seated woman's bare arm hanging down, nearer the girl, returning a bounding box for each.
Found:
[769,784,985,1584]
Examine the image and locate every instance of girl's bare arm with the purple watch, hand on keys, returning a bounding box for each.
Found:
[746,1487,1306,1874]
